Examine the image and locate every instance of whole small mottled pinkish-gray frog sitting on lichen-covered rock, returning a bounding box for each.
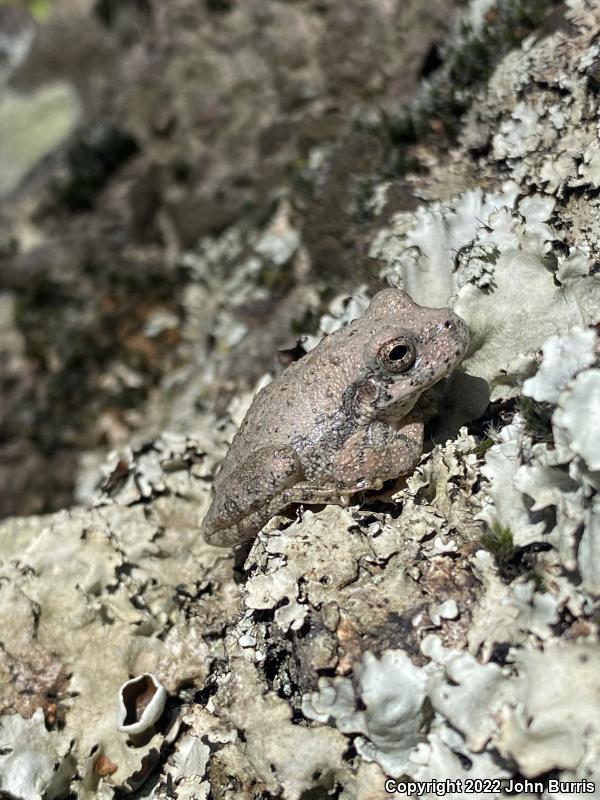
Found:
[202,289,469,546]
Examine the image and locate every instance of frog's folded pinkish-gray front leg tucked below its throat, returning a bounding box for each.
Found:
[333,419,424,491]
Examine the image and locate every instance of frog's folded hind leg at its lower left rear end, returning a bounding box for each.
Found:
[202,447,304,547]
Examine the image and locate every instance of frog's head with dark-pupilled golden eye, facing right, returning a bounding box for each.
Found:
[362,289,469,418]
